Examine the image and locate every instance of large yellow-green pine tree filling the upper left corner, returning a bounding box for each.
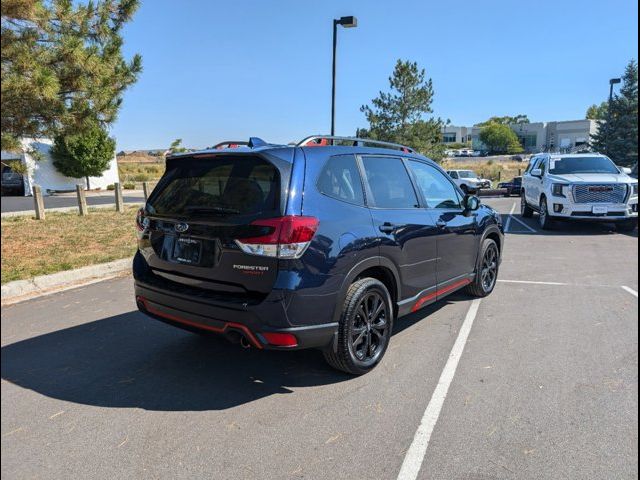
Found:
[0,0,142,150]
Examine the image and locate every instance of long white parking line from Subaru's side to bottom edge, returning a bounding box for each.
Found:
[398,298,480,480]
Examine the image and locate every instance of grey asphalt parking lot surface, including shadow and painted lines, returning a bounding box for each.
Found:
[2,198,638,480]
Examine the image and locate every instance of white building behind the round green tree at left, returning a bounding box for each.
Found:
[2,139,120,195]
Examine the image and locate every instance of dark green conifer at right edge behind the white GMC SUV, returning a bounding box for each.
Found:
[591,60,638,166]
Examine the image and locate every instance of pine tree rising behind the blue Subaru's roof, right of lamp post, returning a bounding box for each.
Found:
[358,60,444,160]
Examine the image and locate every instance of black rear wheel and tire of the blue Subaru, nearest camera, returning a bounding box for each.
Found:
[323,278,394,375]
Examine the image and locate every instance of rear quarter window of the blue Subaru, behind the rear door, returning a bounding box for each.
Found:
[317,155,364,205]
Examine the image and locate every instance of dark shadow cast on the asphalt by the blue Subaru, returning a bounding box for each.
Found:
[2,296,460,411]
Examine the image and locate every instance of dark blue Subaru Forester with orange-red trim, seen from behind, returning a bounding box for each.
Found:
[133,136,504,374]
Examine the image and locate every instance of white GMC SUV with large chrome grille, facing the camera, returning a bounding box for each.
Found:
[520,153,638,231]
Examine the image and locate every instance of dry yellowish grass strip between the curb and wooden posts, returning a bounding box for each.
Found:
[2,207,138,284]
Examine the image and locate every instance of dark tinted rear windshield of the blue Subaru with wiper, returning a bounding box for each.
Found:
[147,157,280,217]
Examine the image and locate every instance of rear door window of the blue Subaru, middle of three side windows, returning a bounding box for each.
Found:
[362,157,418,208]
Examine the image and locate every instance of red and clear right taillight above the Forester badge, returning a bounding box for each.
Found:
[236,215,319,259]
